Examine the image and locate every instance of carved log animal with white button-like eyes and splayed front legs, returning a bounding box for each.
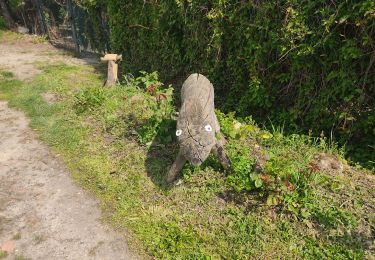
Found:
[167,74,230,182]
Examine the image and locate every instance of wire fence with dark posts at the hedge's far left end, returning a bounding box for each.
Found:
[36,0,109,53]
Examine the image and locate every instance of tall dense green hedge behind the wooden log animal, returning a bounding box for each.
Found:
[78,0,375,167]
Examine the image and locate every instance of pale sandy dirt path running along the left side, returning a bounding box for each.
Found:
[0,36,134,259]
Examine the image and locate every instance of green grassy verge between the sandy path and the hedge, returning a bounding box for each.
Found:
[0,62,375,259]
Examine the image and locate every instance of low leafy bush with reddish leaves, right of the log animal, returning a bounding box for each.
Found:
[217,112,324,215]
